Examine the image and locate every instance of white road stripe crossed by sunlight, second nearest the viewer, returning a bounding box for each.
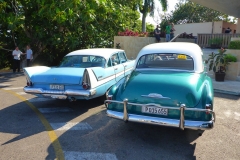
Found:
[50,122,92,131]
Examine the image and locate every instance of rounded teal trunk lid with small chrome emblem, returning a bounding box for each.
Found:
[117,71,203,107]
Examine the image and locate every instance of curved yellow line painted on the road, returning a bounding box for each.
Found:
[2,89,64,160]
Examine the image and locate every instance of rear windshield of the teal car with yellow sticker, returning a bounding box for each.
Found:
[136,53,194,71]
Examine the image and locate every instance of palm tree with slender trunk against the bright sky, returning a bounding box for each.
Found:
[139,0,167,32]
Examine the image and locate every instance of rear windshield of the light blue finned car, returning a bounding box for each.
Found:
[59,55,106,68]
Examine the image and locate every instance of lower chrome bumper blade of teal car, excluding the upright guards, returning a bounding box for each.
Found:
[107,110,214,130]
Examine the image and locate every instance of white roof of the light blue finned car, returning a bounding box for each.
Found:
[66,48,124,60]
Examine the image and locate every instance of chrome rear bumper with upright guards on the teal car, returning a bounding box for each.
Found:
[105,99,216,130]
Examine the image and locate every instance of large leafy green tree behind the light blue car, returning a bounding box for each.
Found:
[0,0,140,67]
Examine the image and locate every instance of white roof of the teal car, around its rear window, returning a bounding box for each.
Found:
[135,42,204,72]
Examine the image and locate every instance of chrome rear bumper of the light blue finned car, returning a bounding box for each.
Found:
[23,86,96,99]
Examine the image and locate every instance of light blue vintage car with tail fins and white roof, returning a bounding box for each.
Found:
[23,48,135,101]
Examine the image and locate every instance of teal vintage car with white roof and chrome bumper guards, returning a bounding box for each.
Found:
[105,42,215,130]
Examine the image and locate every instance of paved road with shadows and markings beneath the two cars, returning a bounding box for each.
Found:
[0,73,240,160]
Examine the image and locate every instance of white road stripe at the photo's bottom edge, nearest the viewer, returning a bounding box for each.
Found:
[64,151,117,160]
